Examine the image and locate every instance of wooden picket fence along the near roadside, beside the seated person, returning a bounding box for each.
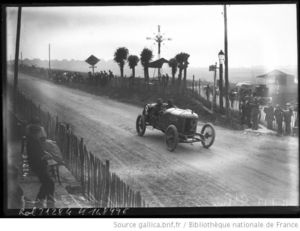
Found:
[16,89,146,207]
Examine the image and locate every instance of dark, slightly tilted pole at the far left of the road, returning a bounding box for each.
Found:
[13,7,22,112]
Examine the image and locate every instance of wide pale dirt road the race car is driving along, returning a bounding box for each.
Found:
[9,74,299,207]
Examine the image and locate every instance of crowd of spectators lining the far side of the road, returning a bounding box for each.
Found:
[20,65,298,135]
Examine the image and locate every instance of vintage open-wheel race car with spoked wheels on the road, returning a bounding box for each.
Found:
[136,103,215,151]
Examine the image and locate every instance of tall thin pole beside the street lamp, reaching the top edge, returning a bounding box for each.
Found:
[224,5,229,119]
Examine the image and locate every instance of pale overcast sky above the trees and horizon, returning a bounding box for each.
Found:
[7,4,297,69]
